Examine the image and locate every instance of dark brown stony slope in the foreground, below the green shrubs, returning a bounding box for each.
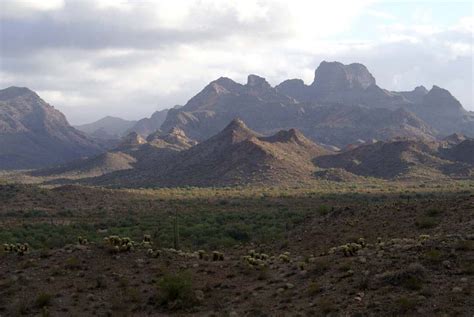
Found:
[0,234,474,316]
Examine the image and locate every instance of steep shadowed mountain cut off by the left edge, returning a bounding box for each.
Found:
[0,87,102,170]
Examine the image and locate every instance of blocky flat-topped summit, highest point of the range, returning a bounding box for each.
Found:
[312,61,376,92]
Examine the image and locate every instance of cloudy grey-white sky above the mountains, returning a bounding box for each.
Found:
[0,0,474,124]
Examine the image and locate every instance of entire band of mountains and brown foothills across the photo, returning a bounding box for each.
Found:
[0,62,474,181]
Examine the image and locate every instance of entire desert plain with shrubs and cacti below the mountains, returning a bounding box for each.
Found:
[0,181,474,316]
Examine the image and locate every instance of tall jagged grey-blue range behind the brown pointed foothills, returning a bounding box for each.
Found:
[162,62,474,147]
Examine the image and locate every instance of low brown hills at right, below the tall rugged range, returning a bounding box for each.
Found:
[314,139,474,179]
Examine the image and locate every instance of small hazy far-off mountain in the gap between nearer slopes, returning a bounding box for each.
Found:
[75,116,137,139]
